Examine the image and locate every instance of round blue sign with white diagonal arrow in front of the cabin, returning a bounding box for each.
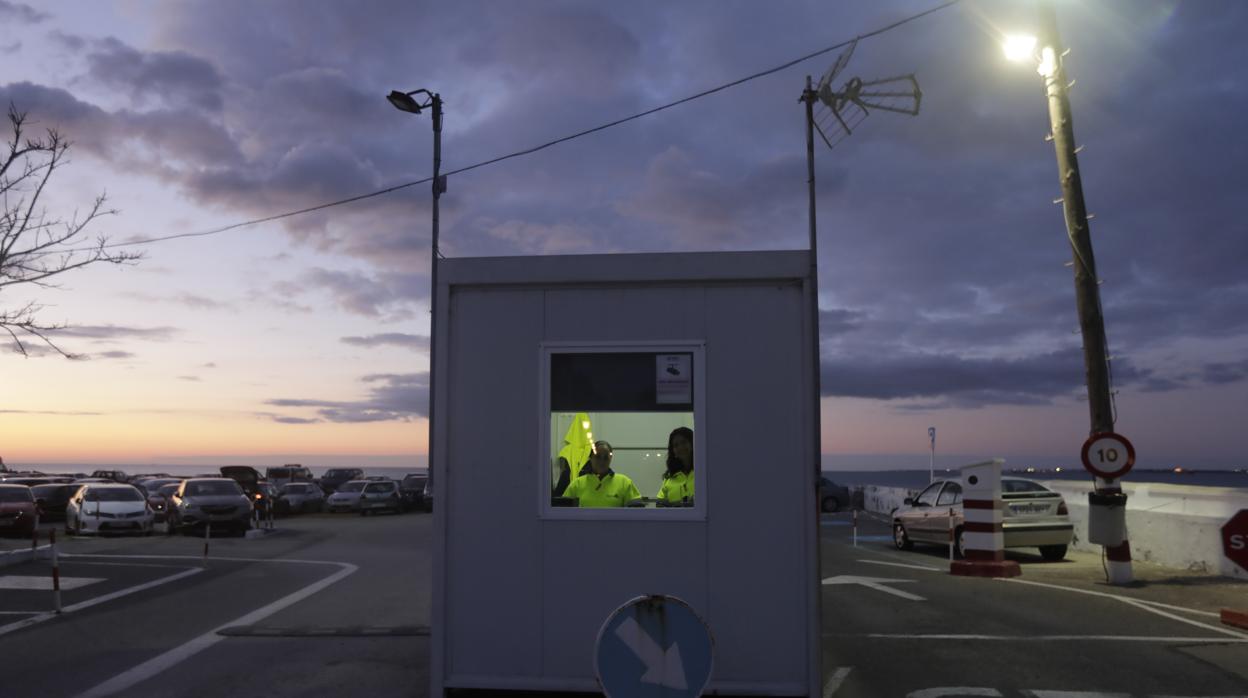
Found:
[594,596,715,698]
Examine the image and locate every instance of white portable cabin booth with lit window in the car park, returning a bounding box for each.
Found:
[431,251,820,696]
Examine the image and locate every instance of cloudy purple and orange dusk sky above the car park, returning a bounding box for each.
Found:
[0,0,1248,468]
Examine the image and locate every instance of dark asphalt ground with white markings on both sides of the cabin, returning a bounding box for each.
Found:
[0,513,1248,698]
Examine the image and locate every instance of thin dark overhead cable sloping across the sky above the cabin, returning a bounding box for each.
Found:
[90,0,961,252]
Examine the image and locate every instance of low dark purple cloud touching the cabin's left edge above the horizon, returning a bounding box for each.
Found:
[266,372,429,423]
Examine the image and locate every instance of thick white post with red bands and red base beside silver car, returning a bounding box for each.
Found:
[948,458,1022,577]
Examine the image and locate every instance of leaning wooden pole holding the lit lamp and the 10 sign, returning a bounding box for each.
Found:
[1040,0,1133,584]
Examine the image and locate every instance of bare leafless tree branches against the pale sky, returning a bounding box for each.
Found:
[0,104,142,358]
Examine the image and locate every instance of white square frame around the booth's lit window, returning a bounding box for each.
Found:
[534,340,710,521]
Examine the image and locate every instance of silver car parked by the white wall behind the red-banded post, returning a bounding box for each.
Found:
[892,477,1075,561]
